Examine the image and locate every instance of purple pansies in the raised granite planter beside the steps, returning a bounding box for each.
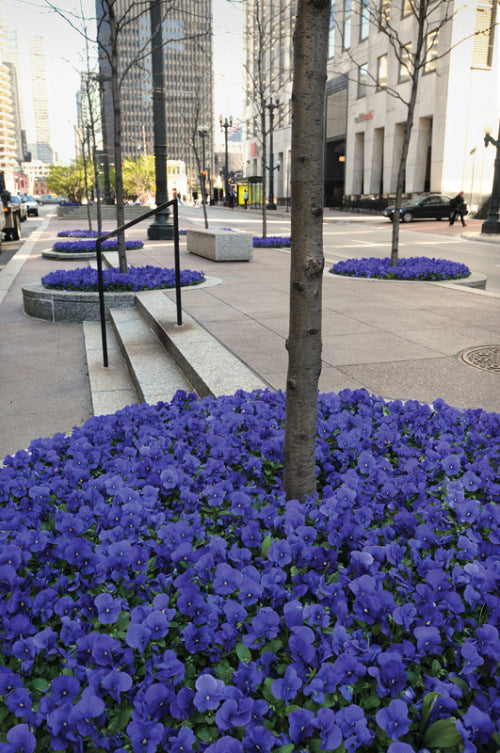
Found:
[41,265,205,292]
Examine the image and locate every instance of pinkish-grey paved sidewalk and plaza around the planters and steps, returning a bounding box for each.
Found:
[0,209,500,458]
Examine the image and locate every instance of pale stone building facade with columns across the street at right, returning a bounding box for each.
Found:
[241,0,500,208]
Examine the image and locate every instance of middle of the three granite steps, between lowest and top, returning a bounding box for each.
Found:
[109,304,195,404]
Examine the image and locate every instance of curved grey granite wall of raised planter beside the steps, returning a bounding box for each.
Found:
[23,285,135,322]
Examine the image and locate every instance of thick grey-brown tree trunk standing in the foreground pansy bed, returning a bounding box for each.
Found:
[284,0,330,500]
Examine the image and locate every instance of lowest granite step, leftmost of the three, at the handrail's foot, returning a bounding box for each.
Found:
[83,322,139,416]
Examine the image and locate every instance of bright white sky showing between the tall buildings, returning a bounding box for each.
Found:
[0,0,243,162]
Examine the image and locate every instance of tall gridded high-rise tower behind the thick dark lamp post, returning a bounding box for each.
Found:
[96,0,213,192]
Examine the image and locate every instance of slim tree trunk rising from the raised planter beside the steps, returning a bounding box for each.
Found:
[108,4,128,272]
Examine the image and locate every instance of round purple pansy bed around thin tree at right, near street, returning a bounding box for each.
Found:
[330,256,470,281]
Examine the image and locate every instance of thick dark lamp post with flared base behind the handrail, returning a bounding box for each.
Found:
[148,0,174,241]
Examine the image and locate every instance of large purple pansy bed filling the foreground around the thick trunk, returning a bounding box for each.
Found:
[0,390,500,753]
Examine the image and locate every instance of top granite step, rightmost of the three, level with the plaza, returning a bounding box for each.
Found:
[132,290,269,397]
